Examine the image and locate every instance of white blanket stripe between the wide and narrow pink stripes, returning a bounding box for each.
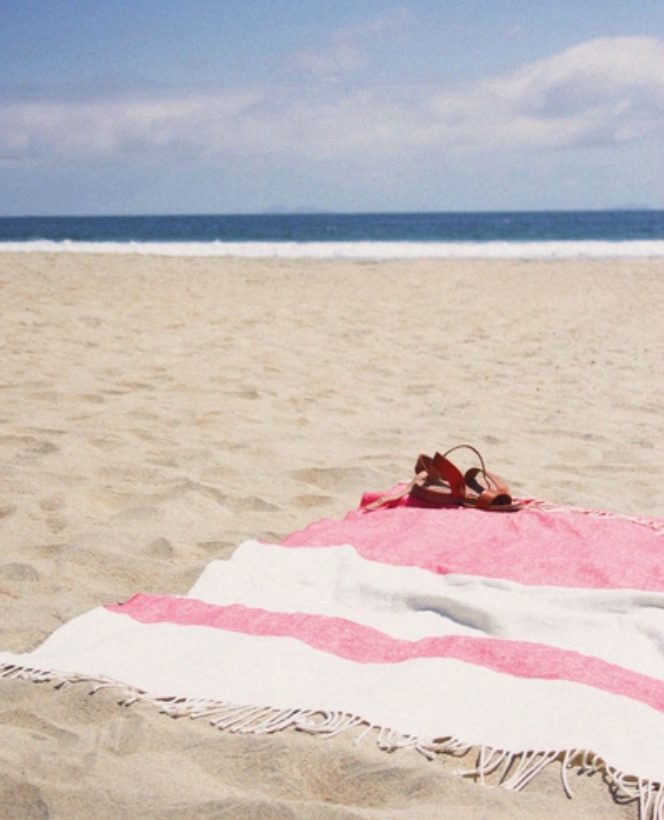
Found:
[189,541,664,679]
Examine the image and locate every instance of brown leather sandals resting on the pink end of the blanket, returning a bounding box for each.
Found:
[365,444,521,512]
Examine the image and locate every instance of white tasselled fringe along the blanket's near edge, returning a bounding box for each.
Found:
[0,664,664,820]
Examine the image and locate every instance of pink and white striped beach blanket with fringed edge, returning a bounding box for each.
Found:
[0,494,664,818]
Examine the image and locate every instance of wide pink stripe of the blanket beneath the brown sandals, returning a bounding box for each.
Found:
[283,494,664,591]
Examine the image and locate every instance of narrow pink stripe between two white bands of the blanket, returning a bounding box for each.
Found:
[106,595,664,712]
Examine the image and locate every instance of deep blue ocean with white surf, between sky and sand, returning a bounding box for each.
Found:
[0,210,664,259]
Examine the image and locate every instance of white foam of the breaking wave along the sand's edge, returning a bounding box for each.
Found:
[0,239,664,260]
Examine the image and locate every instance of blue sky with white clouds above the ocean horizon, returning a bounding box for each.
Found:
[0,0,664,216]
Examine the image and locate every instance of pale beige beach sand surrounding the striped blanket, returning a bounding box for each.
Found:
[0,253,664,820]
